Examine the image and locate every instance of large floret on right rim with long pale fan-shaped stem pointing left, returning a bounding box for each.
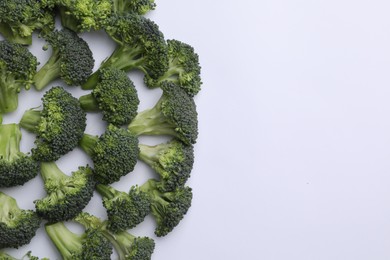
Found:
[128,82,198,144]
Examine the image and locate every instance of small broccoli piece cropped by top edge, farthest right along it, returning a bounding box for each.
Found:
[113,0,156,15]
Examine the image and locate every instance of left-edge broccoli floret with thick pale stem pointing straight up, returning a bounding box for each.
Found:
[0,124,39,187]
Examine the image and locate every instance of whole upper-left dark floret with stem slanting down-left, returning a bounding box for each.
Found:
[34,29,95,90]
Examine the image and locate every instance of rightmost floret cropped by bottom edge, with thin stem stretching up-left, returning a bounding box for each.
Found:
[75,212,155,260]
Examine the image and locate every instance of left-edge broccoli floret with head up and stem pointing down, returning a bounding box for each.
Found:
[0,41,38,114]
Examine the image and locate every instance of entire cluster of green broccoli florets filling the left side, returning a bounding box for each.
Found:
[0,0,202,260]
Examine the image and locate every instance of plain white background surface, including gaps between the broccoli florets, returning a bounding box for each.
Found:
[5,0,390,260]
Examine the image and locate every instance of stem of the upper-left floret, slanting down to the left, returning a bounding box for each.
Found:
[34,50,61,90]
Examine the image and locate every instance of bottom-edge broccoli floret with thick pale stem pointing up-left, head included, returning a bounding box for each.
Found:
[45,222,112,260]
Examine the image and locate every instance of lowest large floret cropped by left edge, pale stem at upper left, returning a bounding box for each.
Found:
[0,192,41,248]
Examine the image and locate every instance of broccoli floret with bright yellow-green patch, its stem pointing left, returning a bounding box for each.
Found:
[20,87,86,161]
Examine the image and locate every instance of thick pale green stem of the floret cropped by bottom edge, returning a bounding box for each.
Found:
[45,222,82,260]
